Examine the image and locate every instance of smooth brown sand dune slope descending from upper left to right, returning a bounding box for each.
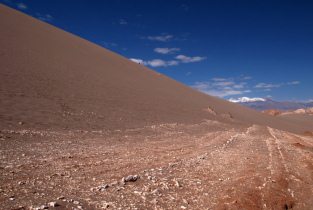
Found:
[0,5,309,132]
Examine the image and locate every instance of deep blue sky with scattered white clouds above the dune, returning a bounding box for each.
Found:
[0,0,313,101]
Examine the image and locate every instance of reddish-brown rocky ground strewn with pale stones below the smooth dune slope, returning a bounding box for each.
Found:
[0,121,313,210]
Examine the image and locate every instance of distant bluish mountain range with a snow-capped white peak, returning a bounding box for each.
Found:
[229,97,313,111]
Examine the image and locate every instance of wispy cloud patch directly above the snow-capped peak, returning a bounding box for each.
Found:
[191,78,251,98]
